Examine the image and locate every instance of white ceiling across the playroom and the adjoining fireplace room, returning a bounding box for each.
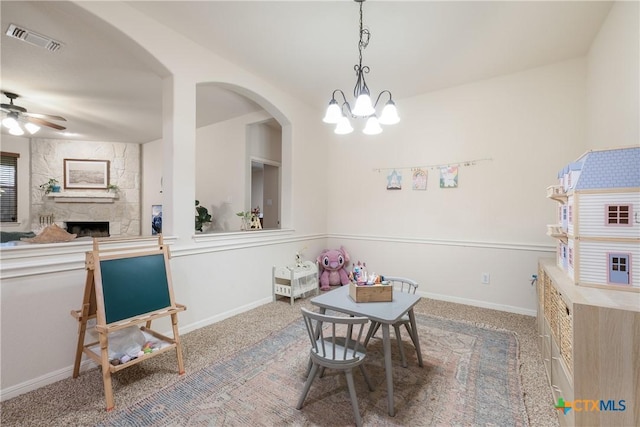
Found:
[0,0,612,142]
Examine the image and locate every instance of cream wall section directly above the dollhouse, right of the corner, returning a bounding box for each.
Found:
[587,1,640,149]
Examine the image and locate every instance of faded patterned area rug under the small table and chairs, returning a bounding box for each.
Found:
[102,314,528,426]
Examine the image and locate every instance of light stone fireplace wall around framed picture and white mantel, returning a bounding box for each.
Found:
[30,138,141,236]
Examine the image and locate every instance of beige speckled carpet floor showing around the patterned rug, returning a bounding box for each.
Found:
[0,299,558,426]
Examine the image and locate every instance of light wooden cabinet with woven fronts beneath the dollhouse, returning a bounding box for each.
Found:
[537,259,640,426]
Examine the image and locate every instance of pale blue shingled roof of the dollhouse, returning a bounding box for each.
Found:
[570,147,640,190]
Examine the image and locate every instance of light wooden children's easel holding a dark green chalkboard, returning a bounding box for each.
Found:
[71,234,186,410]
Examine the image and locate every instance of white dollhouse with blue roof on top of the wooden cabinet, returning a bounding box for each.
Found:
[547,147,640,291]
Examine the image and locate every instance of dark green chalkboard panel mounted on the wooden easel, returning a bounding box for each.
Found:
[100,254,172,324]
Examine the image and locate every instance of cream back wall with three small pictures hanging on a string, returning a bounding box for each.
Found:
[327,59,586,314]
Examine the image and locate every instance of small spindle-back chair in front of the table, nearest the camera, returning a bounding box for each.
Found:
[296,307,373,427]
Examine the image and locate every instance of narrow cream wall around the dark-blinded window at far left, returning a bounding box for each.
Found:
[0,134,31,231]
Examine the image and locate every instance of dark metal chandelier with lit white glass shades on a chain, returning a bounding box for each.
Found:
[322,0,400,135]
